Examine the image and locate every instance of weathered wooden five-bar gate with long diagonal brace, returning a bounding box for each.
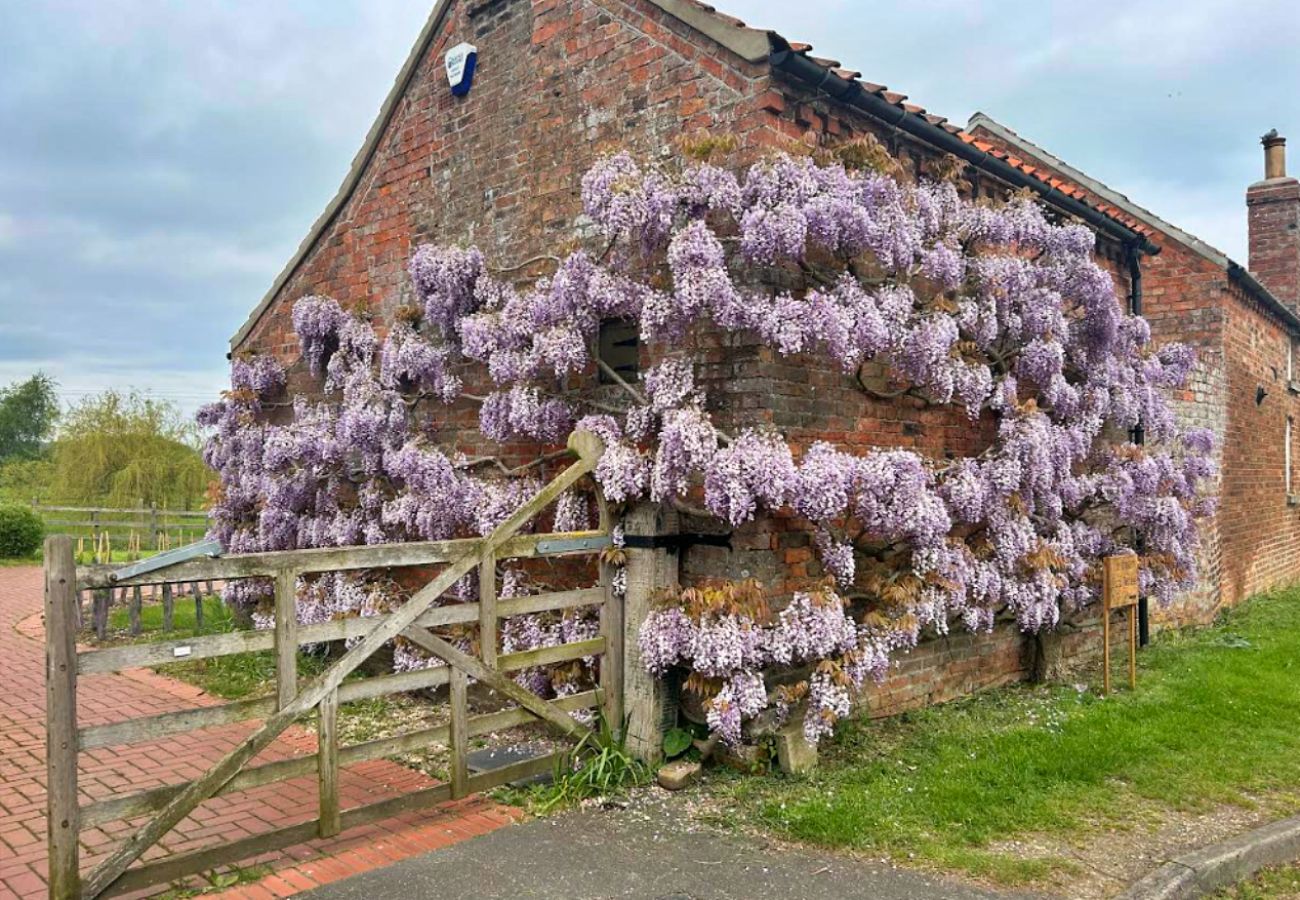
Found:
[46,432,623,897]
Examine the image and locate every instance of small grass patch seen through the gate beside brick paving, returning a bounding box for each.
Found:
[108,596,326,700]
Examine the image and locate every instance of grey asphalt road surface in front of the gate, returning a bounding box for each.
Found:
[303,808,1030,900]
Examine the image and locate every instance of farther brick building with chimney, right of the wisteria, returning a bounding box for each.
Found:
[969,113,1300,623]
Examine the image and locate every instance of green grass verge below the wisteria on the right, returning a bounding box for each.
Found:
[715,589,1300,883]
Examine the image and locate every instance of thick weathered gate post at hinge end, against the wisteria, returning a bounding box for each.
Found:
[623,503,679,762]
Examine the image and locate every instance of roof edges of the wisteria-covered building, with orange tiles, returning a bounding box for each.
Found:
[230,0,1164,347]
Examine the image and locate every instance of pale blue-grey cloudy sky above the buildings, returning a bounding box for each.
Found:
[0,0,1300,410]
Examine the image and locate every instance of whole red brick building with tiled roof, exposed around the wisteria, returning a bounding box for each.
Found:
[233,0,1300,711]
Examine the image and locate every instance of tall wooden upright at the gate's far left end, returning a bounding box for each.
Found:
[46,535,81,900]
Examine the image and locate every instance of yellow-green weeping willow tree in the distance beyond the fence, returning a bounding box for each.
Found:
[52,390,212,509]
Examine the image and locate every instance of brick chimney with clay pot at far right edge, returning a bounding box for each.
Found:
[1245,129,1300,312]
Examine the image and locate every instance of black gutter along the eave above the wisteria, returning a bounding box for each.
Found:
[771,49,1160,256]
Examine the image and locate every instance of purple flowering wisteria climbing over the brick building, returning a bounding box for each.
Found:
[204,137,1213,741]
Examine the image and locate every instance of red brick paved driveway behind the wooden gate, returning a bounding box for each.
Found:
[0,568,517,897]
